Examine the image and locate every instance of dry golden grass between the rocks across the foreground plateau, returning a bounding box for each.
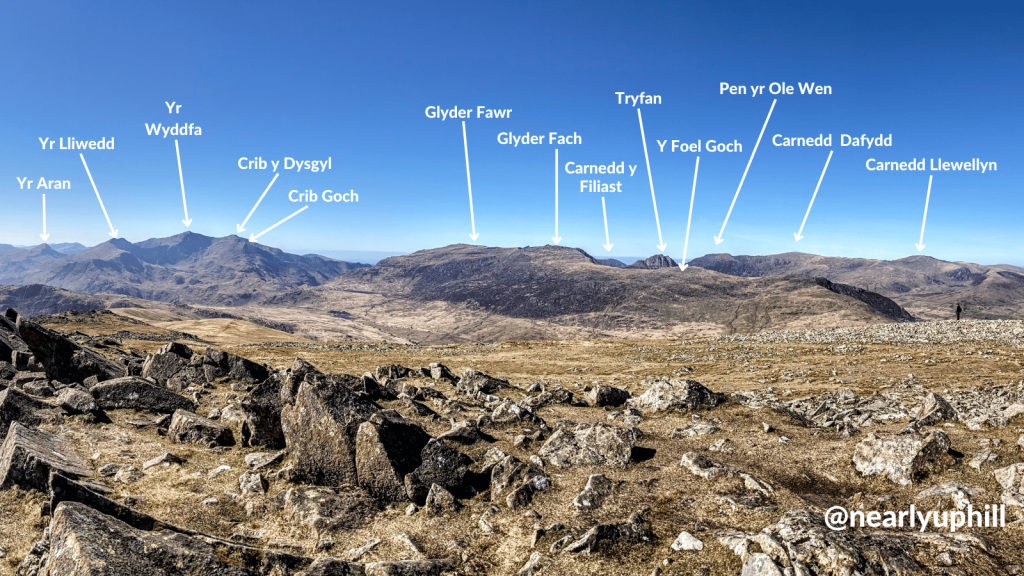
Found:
[8,311,1024,576]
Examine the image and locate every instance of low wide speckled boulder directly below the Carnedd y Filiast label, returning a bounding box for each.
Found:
[539,422,635,467]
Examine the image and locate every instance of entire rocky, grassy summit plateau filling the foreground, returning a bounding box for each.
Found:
[0,303,1024,576]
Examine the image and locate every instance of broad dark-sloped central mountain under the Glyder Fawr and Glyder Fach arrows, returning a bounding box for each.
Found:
[256,245,910,342]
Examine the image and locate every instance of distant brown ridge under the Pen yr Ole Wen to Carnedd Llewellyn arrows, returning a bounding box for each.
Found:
[690,252,1024,320]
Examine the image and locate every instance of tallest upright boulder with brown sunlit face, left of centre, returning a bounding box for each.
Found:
[281,377,377,486]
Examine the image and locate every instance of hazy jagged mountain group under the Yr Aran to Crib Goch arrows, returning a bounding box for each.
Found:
[0,232,366,305]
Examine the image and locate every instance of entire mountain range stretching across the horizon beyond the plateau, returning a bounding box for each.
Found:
[0,233,1011,343]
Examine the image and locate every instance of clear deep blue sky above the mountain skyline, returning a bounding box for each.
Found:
[0,1,1024,264]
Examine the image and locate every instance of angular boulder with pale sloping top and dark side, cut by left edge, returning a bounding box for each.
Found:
[0,422,91,492]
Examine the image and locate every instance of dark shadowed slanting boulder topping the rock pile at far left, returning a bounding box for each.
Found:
[17,316,126,382]
